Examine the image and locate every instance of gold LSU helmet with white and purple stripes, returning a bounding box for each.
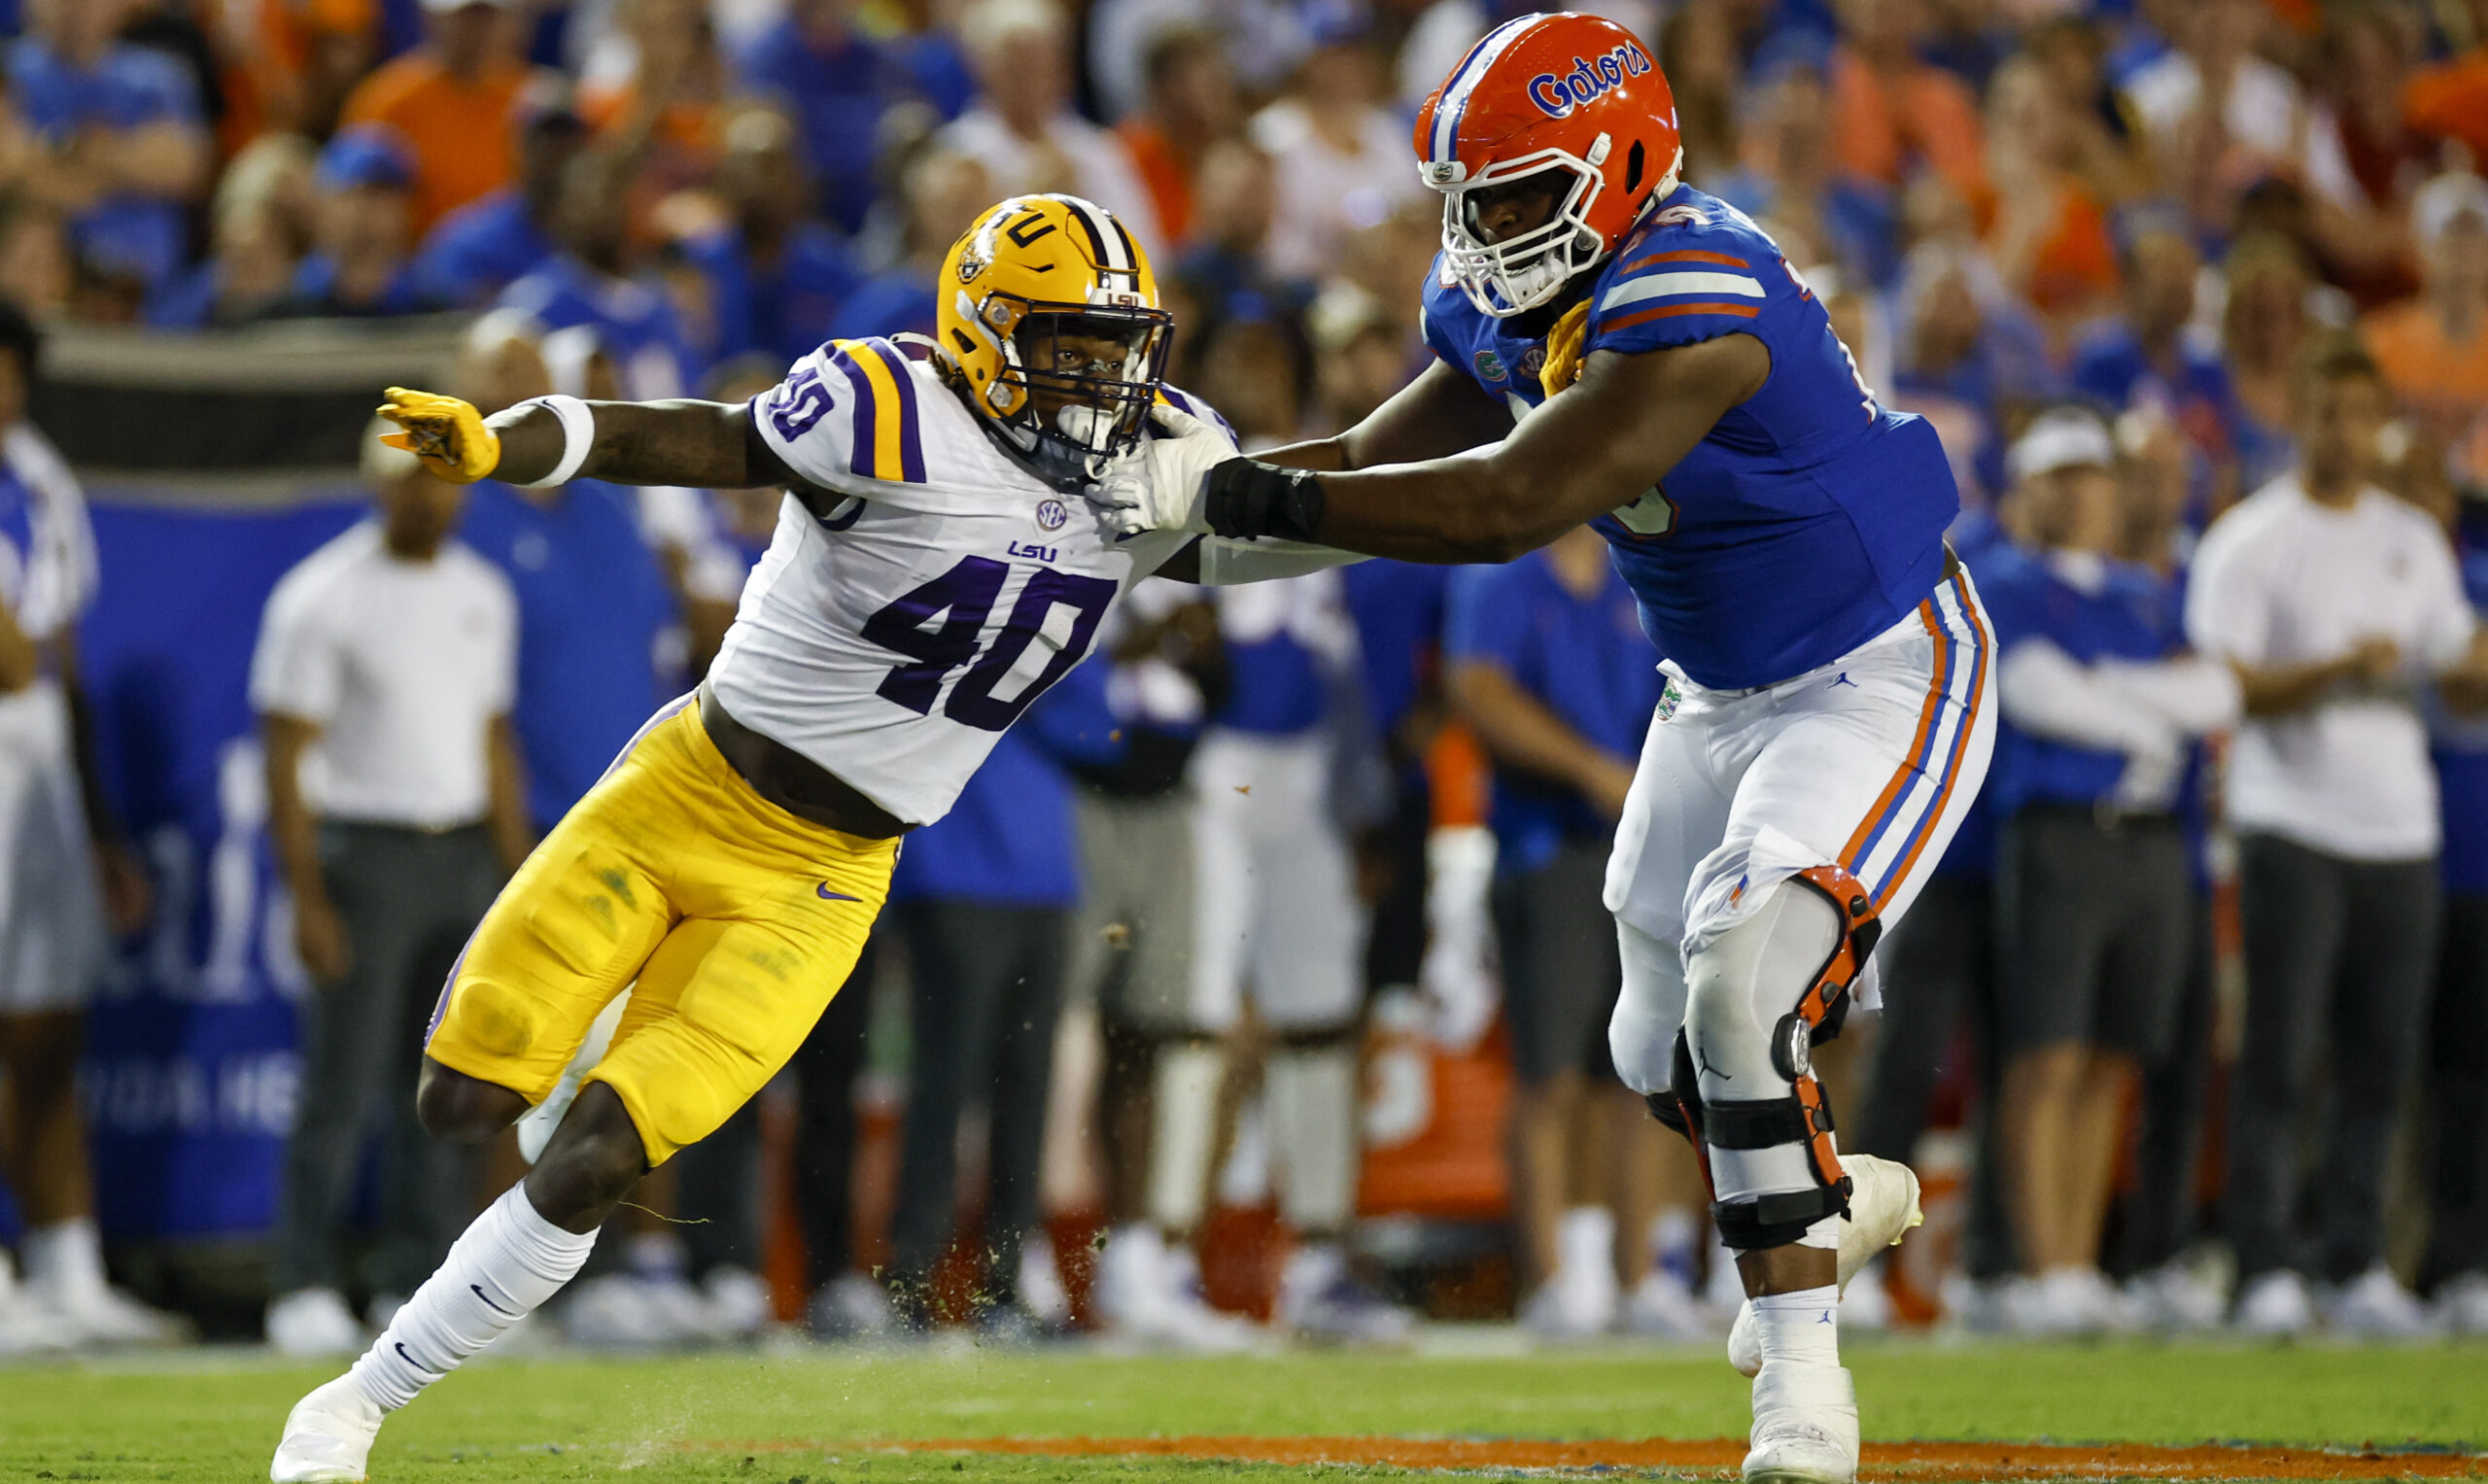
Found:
[936,194,1174,483]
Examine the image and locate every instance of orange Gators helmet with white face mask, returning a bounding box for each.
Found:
[1416,13,1684,319]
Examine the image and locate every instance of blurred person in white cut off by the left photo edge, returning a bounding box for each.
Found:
[0,304,179,1355]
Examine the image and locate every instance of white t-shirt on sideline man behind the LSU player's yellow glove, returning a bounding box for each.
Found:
[252,520,517,829]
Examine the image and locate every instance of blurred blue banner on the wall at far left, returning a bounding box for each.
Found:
[80,488,363,1240]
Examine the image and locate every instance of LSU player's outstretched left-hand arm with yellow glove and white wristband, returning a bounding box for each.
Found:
[381,386,796,491]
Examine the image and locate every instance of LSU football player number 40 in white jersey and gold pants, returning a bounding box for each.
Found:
[268,196,1354,1484]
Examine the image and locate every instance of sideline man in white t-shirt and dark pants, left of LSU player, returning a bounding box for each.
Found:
[252,424,530,1355]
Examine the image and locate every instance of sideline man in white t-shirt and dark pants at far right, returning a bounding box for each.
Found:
[2187,341,2488,1334]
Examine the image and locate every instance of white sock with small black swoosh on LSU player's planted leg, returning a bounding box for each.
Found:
[346,1186,597,1412]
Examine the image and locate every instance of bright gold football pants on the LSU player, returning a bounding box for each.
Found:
[426,703,898,1165]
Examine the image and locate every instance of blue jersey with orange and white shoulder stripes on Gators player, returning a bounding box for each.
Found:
[1426,187,1960,690]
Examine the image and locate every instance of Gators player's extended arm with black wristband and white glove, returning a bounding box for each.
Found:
[1144,333,1772,563]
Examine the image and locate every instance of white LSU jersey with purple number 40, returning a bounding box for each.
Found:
[709,338,1209,824]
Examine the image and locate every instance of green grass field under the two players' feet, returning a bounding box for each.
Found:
[0,1342,2488,1484]
